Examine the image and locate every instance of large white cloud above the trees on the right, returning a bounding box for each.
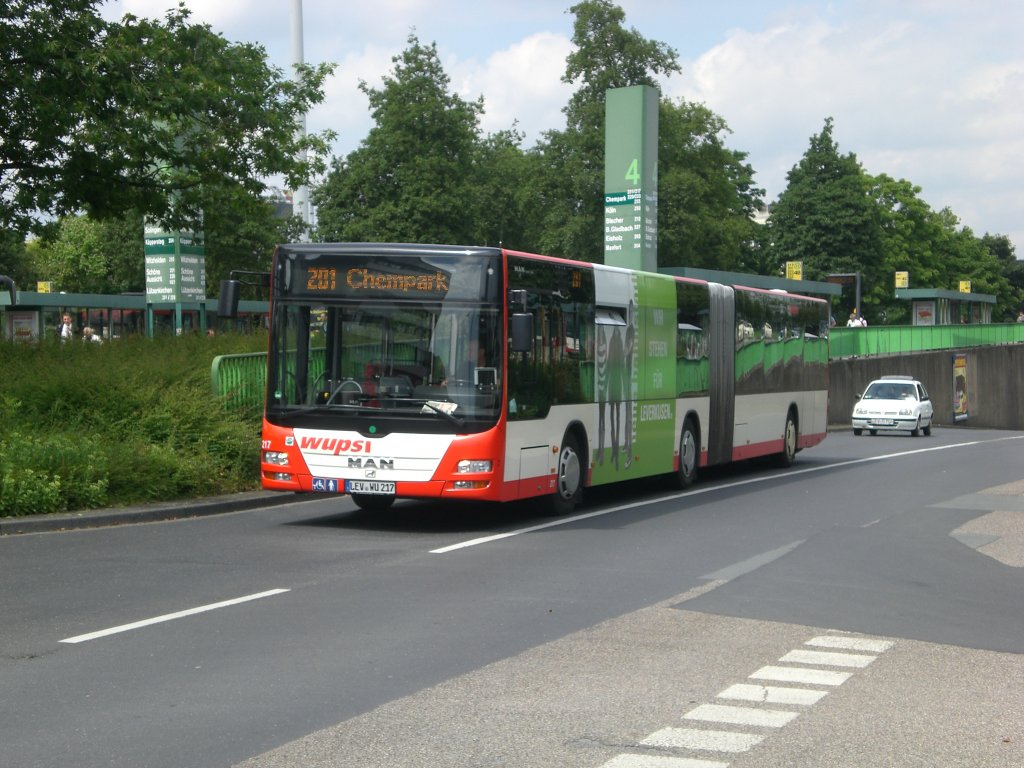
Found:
[669,12,1024,245]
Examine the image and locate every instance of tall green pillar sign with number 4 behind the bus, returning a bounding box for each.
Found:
[604,85,658,272]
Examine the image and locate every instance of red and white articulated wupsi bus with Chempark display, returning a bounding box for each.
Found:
[261,243,828,514]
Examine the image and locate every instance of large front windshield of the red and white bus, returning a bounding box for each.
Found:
[266,247,505,433]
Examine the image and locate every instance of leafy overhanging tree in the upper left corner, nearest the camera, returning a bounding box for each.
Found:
[0,0,333,233]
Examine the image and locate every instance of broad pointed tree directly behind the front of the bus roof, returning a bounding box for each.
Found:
[312,35,483,243]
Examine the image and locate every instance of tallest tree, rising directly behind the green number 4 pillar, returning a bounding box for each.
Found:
[532,0,680,261]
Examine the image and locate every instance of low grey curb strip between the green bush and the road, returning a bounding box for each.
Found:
[0,490,315,536]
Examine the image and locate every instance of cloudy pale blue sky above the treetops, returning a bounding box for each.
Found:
[102,0,1024,258]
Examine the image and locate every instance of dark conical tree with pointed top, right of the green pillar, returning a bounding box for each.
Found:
[768,118,883,315]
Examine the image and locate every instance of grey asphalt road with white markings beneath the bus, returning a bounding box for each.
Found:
[0,428,1024,768]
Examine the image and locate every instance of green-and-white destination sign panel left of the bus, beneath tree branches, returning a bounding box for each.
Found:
[145,228,206,304]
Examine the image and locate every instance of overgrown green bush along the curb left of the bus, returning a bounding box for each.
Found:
[0,335,266,515]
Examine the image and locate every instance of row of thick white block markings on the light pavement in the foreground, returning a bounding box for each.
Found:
[602,635,893,768]
